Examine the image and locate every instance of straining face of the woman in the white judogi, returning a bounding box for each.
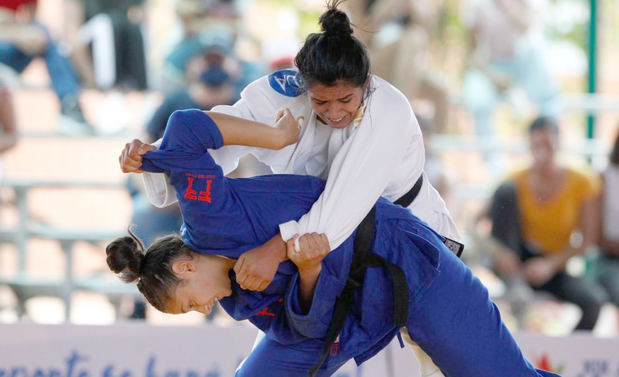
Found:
[307,80,369,128]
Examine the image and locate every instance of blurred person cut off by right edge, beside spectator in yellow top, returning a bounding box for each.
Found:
[594,133,619,307]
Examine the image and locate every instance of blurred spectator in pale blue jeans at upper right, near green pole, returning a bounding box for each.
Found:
[462,0,559,140]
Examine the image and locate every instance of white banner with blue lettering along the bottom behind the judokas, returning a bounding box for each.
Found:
[0,323,619,377]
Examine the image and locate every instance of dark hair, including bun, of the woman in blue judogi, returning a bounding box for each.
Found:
[105,230,191,312]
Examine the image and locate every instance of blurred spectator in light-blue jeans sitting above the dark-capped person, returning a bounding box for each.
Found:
[162,0,266,100]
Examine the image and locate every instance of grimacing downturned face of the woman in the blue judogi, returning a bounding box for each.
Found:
[166,254,234,314]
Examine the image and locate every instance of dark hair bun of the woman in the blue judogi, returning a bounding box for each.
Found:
[105,237,144,283]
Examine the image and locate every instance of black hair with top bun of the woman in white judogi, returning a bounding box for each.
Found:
[294,0,370,88]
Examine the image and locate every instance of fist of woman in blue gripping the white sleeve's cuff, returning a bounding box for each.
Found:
[286,233,331,271]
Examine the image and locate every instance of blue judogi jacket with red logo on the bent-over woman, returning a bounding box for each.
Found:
[141,110,441,366]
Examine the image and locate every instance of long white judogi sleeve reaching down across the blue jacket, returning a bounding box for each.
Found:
[279,87,425,250]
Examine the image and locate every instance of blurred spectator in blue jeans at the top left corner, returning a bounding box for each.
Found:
[0,0,93,134]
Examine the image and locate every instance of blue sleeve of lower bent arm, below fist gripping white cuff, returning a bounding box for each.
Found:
[284,268,341,338]
